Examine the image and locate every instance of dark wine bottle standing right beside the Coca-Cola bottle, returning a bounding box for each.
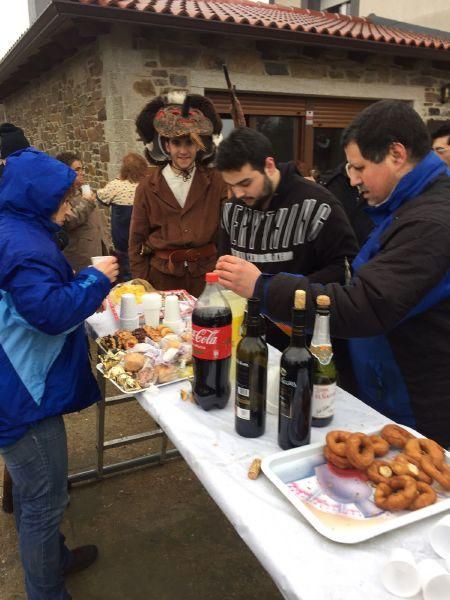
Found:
[235,298,268,437]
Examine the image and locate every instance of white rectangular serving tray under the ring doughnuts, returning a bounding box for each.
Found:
[261,428,450,544]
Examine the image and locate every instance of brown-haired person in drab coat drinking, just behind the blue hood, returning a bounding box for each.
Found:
[56,152,104,272]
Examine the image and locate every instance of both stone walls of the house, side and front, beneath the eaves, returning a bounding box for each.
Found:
[5,26,450,186]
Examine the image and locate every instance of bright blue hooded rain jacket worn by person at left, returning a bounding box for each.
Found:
[0,148,110,446]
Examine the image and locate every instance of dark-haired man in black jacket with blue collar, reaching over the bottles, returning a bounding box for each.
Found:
[216,100,450,446]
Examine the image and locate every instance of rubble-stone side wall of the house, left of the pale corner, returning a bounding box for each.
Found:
[5,43,110,187]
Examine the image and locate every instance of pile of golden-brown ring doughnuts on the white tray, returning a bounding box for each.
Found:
[323,424,450,511]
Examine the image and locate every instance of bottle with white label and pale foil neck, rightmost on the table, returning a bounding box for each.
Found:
[310,296,337,427]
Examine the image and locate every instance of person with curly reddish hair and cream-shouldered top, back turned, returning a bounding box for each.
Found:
[97,152,149,281]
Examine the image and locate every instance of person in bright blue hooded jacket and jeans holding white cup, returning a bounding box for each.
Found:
[0,148,118,600]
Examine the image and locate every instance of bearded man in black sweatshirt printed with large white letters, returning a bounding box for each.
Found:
[216,127,357,356]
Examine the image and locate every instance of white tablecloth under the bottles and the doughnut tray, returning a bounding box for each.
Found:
[139,383,448,600]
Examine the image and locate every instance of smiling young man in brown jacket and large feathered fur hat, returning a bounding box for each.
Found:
[129,94,227,296]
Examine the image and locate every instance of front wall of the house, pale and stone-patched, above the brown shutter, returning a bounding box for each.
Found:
[101,27,450,176]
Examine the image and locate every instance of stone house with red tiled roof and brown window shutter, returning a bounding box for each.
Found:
[0,0,450,186]
